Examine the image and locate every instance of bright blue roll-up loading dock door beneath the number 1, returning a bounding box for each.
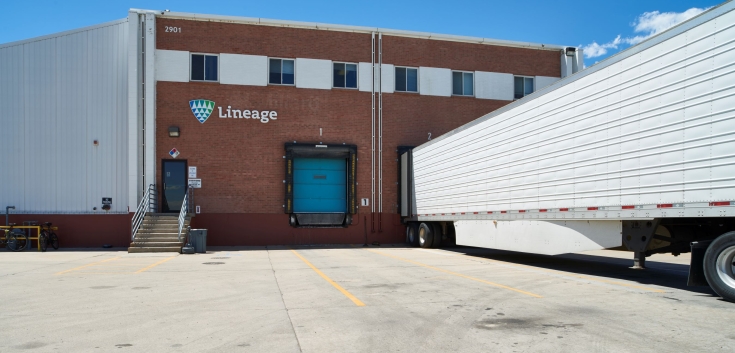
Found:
[293,158,347,213]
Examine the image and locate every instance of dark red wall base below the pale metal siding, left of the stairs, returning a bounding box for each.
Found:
[6,213,133,248]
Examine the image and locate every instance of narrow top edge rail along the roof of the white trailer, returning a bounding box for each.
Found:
[414,0,735,151]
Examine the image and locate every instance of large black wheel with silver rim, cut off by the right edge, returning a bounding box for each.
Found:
[704,232,735,302]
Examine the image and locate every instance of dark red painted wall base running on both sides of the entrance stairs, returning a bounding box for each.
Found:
[0,213,406,248]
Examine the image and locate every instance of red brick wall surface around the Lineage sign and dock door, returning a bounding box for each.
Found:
[156,19,560,245]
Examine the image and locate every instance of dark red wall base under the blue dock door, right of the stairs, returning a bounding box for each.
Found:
[192,213,406,246]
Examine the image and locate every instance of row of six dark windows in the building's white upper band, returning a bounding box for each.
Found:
[191,54,534,99]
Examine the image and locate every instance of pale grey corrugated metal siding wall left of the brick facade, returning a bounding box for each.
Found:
[0,21,128,213]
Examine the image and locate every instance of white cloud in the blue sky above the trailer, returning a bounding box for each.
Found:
[582,7,709,59]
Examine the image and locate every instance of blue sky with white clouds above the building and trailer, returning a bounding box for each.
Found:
[0,0,722,66]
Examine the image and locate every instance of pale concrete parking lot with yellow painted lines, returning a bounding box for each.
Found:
[0,245,735,352]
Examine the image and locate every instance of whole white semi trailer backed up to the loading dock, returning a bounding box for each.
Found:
[399,2,735,301]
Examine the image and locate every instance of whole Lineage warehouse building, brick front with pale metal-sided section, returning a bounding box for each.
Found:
[0,10,581,246]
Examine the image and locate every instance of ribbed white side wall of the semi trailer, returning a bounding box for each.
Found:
[414,4,735,217]
